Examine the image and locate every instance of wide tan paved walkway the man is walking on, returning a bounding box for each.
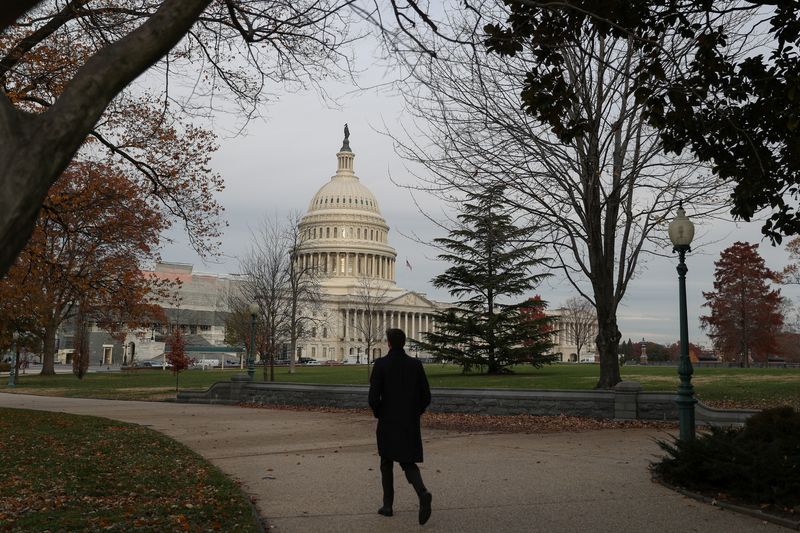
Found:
[0,393,788,533]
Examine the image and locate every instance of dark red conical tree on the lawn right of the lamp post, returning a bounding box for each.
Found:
[700,242,783,366]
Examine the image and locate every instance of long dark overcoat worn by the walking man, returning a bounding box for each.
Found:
[369,349,431,463]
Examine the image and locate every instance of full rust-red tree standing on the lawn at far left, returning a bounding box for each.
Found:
[0,162,172,375]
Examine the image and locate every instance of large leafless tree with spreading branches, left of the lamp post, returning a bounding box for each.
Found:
[394,1,725,388]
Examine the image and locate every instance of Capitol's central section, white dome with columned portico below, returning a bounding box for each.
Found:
[298,129,445,362]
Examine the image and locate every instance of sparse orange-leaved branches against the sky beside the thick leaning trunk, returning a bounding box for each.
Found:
[0,9,223,262]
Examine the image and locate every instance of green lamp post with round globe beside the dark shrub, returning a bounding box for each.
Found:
[669,202,697,441]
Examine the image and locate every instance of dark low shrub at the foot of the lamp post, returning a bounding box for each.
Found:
[651,407,800,507]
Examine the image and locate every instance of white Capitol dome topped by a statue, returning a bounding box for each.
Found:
[299,125,397,288]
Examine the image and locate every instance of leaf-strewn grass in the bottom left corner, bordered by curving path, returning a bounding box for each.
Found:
[0,409,259,532]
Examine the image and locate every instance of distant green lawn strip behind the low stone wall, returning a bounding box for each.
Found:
[0,364,800,409]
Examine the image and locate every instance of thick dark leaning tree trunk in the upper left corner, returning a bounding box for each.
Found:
[0,0,216,276]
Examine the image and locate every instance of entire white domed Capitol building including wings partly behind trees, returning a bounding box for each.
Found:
[59,129,594,365]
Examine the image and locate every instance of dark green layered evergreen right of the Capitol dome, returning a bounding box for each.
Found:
[420,185,555,374]
